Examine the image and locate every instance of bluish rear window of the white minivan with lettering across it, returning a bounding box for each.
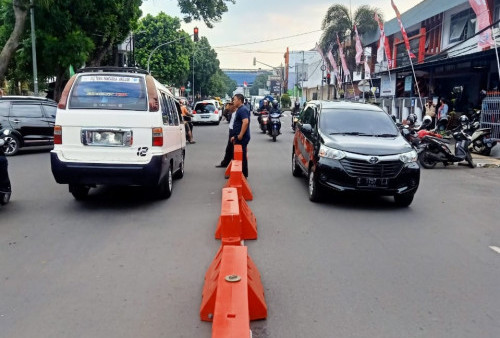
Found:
[69,75,148,111]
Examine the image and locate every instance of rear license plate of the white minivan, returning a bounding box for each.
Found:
[82,129,133,147]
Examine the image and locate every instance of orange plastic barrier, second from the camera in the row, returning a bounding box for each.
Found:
[215,188,257,240]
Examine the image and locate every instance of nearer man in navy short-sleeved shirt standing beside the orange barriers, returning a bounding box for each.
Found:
[231,94,250,177]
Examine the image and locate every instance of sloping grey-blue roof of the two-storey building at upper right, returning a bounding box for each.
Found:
[362,0,469,46]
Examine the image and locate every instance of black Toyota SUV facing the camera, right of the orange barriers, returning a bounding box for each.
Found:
[292,101,420,206]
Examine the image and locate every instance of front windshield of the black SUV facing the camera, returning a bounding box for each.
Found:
[319,109,398,137]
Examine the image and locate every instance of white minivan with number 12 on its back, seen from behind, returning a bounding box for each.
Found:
[51,67,186,200]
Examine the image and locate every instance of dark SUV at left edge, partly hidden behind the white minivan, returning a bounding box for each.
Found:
[0,96,57,156]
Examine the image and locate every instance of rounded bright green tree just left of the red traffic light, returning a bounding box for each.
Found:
[135,12,193,86]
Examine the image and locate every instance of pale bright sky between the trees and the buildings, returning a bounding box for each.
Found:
[141,0,422,69]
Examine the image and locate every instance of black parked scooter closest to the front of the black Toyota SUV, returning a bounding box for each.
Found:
[418,128,475,169]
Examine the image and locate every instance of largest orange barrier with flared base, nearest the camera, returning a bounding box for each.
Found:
[200,245,267,324]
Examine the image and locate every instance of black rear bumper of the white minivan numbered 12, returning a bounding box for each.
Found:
[50,152,164,186]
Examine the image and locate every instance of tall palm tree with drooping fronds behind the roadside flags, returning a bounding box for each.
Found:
[320,4,383,69]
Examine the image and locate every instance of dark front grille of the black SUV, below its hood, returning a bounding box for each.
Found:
[340,159,403,178]
